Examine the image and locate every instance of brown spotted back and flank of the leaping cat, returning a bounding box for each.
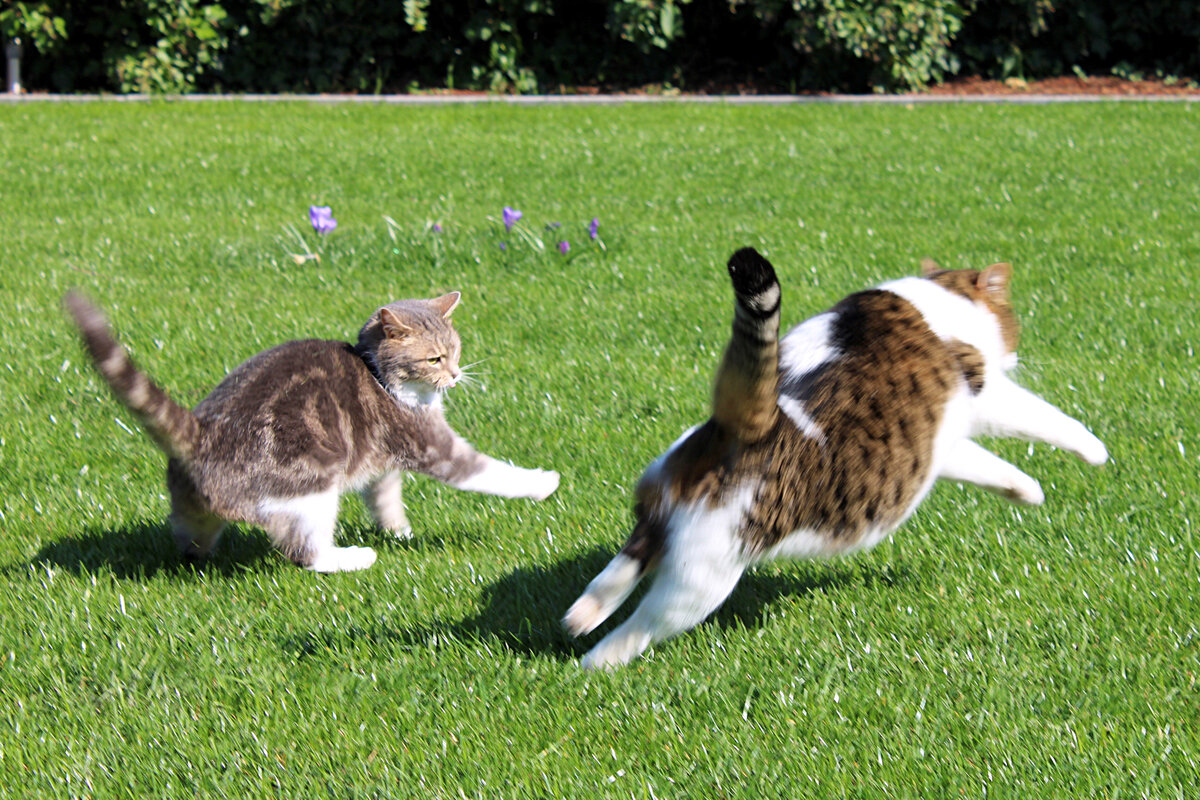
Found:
[746,288,964,549]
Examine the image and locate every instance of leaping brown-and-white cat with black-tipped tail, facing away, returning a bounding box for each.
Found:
[564,248,1108,668]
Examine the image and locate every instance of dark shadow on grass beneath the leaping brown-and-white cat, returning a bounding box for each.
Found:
[283,548,905,661]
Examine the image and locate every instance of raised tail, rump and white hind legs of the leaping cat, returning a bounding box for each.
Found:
[564,248,780,666]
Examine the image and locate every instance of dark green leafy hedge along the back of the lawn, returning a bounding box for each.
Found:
[7,0,1200,92]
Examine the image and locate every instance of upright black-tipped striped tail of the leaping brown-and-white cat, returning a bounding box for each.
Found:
[713,247,780,443]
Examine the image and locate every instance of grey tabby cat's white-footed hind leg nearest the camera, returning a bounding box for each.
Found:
[257,489,376,572]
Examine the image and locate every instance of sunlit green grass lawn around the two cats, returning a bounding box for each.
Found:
[0,102,1200,799]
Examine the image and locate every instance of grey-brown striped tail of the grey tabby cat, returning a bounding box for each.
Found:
[62,291,200,461]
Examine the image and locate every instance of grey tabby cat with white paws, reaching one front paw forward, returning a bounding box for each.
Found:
[64,291,558,572]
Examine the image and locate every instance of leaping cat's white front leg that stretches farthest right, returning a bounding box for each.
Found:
[976,378,1109,467]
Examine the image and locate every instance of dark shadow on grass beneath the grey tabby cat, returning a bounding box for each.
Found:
[30,522,275,581]
